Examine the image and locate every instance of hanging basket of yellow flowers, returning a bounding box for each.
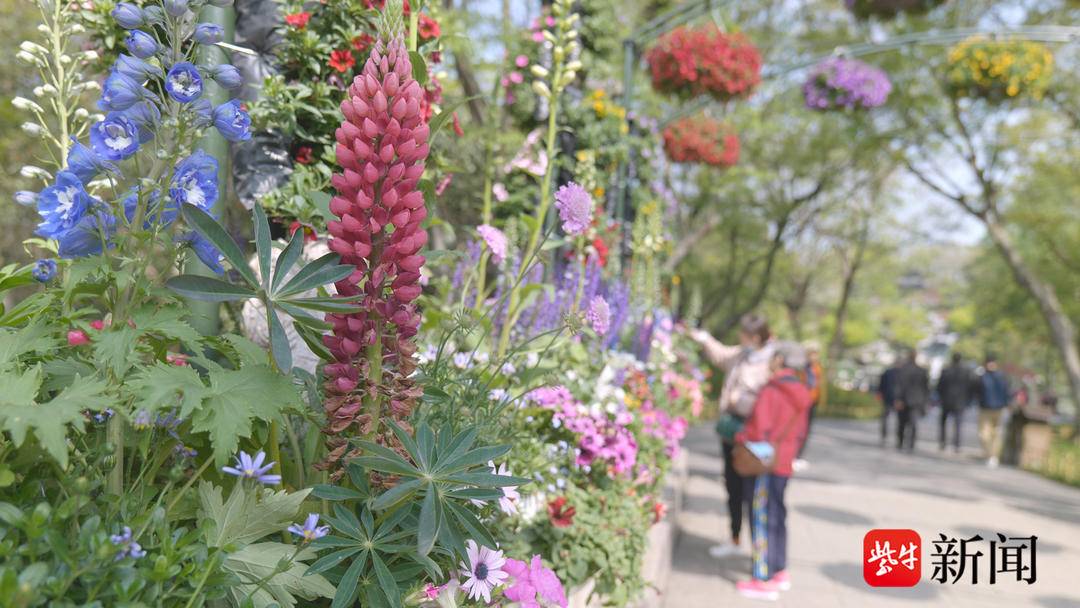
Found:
[946,36,1054,100]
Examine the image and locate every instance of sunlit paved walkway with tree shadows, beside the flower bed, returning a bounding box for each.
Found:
[664,418,1080,608]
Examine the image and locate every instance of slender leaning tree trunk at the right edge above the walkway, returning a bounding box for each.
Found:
[982,214,1080,431]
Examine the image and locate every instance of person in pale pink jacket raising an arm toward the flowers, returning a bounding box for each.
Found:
[690,313,772,558]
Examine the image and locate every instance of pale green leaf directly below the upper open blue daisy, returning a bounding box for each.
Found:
[199,482,311,546]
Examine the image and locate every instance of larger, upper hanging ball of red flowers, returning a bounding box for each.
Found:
[645,25,761,100]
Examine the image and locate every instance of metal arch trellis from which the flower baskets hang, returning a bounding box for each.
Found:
[615,0,1080,221]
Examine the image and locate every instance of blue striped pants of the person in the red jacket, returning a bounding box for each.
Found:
[746,475,787,581]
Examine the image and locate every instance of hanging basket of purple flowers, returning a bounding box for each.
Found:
[802,57,892,110]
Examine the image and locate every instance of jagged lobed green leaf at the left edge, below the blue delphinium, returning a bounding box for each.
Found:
[0,366,113,469]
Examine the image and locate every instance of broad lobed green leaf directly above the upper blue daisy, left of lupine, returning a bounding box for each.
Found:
[191,365,300,464]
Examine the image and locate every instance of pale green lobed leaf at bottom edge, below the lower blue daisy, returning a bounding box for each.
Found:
[222,542,335,608]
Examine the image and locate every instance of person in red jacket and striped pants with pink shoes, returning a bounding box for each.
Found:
[735,342,812,599]
